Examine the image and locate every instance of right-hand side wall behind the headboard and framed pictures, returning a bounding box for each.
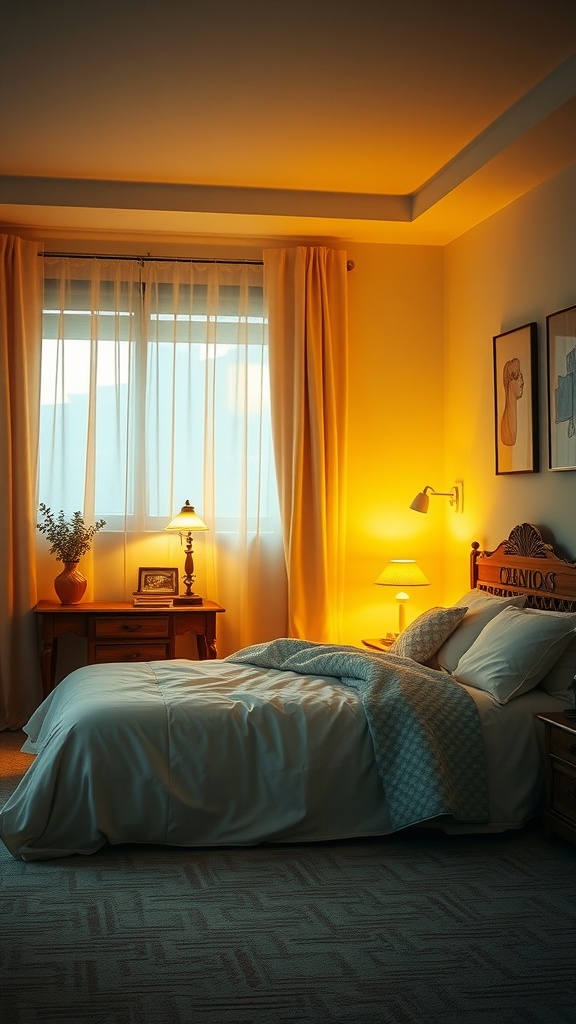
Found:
[444,159,576,601]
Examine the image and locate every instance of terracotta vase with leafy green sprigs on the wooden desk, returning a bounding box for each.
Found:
[37,503,106,604]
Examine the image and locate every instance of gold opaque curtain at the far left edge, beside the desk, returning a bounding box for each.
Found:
[0,234,42,729]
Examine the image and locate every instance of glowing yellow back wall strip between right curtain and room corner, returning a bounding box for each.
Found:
[342,245,444,644]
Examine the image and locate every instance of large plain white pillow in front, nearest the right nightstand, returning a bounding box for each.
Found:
[452,606,576,705]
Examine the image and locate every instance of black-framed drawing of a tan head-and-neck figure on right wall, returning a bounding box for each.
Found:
[493,322,538,475]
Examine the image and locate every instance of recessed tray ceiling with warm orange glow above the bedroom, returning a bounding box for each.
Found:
[0,0,576,245]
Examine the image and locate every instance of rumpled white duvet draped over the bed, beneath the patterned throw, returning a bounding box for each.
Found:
[0,660,561,860]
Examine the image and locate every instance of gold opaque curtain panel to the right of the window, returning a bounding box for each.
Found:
[263,246,347,643]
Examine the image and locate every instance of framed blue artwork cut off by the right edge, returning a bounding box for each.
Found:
[546,306,576,470]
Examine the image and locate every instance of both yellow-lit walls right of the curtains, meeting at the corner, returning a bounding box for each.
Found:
[343,159,576,643]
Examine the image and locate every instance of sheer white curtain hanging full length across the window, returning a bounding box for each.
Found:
[39,258,286,655]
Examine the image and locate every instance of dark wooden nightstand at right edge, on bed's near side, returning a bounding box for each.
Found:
[536,712,576,843]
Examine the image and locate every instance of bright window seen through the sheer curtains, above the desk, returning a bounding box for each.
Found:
[39,260,278,529]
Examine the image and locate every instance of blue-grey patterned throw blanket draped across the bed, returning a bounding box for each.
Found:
[227,639,488,829]
